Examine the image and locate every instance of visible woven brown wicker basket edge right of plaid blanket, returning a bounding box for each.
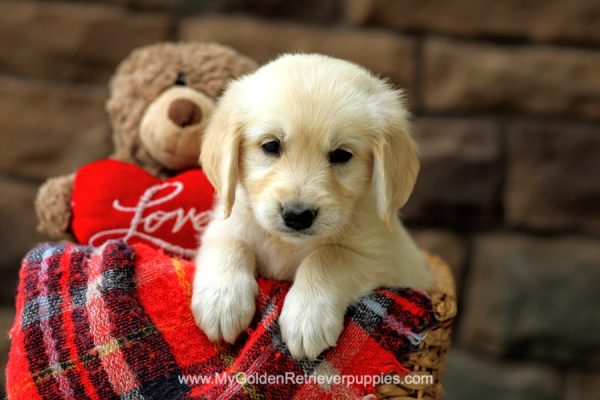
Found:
[377,254,456,400]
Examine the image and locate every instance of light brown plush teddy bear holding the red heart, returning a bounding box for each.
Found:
[35,43,257,238]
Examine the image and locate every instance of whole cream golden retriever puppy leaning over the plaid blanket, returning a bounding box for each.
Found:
[192,54,431,359]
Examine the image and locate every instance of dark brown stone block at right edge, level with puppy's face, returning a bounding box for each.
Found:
[505,122,600,233]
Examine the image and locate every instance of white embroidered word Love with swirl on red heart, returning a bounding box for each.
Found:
[88,182,212,257]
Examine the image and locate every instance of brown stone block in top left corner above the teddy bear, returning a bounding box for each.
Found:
[0,1,170,83]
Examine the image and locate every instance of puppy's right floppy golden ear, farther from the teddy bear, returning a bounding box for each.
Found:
[373,89,419,226]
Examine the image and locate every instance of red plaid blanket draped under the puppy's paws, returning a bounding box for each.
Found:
[7,241,436,400]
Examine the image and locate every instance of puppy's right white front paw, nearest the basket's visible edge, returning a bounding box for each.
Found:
[279,287,345,360]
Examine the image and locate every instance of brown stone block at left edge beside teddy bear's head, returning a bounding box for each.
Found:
[0,77,111,180]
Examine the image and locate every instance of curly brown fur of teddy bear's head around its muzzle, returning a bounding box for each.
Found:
[106,43,256,175]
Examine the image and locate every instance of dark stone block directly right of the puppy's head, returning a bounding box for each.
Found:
[402,118,502,228]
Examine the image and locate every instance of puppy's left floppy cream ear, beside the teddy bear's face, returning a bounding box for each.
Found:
[200,90,241,218]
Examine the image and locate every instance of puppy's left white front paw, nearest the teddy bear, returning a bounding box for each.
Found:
[192,274,258,343]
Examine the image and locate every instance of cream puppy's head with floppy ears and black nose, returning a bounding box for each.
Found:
[200,54,419,240]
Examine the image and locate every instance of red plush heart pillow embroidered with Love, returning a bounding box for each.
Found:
[71,160,214,258]
